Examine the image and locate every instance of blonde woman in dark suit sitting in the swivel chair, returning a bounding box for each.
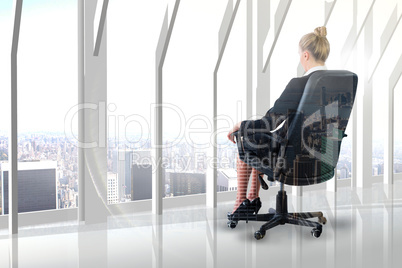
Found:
[227,26,330,219]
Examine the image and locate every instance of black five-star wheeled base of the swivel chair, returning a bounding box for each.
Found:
[228,190,327,240]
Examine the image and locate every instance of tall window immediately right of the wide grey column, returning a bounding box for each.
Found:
[107,0,166,204]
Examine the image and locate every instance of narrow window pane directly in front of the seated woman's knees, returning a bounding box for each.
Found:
[214,2,250,192]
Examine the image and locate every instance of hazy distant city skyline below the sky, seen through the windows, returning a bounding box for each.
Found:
[0,129,402,213]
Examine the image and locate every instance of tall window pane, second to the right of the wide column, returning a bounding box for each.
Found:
[163,1,228,198]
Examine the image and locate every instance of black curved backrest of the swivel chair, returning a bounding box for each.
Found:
[278,70,358,185]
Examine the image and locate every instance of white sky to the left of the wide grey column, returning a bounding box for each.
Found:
[0,0,77,132]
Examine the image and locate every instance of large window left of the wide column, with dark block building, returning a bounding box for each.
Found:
[0,0,78,214]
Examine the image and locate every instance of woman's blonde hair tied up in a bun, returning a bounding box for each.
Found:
[299,26,330,62]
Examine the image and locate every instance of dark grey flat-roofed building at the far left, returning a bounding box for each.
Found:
[0,161,57,215]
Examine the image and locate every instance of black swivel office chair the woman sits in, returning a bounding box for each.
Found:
[228,71,358,240]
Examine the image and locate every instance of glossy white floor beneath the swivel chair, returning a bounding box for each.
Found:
[0,181,402,268]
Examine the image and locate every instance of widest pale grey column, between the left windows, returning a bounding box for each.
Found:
[78,0,109,224]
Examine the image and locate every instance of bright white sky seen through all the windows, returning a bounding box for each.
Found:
[0,0,402,144]
